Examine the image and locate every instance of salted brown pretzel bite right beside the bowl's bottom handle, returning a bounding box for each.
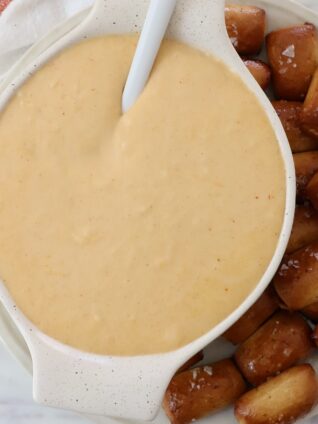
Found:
[163,359,246,424]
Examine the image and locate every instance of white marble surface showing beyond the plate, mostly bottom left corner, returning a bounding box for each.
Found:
[0,0,318,424]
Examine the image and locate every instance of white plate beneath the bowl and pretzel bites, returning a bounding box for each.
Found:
[0,0,318,424]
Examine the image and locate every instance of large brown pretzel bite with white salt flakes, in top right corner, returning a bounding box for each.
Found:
[266,23,318,101]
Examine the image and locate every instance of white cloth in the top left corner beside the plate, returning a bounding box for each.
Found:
[0,0,318,76]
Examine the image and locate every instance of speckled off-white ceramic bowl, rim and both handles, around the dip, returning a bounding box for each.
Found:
[0,0,296,422]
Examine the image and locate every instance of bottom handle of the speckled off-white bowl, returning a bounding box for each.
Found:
[27,329,185,421]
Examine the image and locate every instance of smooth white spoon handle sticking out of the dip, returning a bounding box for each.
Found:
[122,0,177,113]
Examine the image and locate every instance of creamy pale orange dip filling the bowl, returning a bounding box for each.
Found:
[0,36,286,355]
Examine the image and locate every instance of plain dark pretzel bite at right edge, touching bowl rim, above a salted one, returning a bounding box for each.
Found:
[287,204,318,253]
